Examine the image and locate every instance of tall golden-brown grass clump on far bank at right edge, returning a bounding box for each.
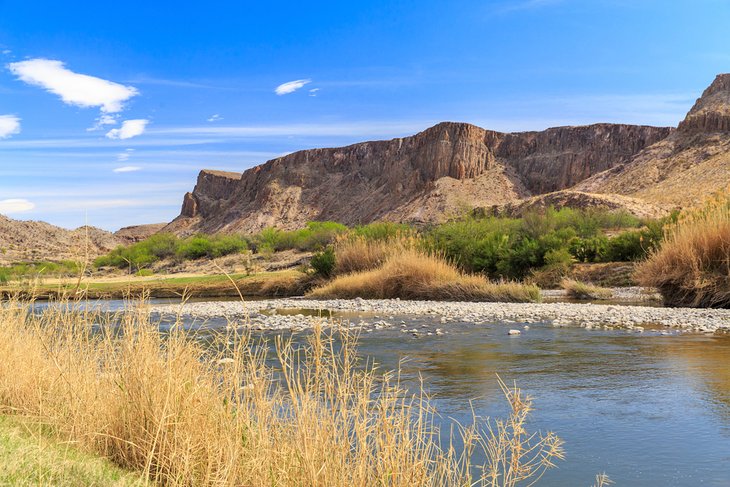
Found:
[636,192,730,308]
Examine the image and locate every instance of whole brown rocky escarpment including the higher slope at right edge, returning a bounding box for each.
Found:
[166,74,730,234]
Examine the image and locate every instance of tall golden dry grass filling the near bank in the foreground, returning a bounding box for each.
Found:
[0,301,563,487]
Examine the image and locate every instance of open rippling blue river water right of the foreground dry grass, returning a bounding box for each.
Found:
[41,303,730,487]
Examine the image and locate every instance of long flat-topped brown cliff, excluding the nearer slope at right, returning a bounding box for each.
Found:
[166,122,671,233]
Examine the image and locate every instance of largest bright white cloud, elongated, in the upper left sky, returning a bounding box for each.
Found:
[8,59,139,113]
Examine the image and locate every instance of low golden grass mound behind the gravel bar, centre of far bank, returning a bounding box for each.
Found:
[310,249,540,302]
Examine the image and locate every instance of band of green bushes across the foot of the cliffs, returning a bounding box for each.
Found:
[89,208,667,279]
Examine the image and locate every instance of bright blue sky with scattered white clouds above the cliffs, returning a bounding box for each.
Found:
[0,0,730,230]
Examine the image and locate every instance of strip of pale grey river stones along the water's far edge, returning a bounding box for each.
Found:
[151,298,730,332]
